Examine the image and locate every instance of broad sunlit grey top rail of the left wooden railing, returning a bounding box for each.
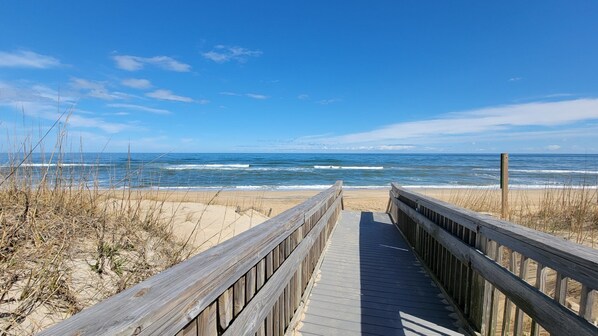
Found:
[41,183,342,335]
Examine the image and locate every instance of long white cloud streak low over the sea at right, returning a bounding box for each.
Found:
[306,99,598,144]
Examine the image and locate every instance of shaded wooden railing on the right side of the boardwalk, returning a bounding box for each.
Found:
[389,184,598,336]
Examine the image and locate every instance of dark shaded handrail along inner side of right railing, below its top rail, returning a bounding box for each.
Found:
[393,199,597,336]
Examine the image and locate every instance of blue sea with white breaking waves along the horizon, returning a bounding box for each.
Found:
[0,153,598,190]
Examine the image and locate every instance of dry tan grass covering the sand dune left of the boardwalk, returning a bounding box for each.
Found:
[0,117,191,335]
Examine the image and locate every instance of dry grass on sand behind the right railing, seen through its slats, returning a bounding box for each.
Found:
[448,186,598,335]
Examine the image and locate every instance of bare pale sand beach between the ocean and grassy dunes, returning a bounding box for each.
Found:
[120,188,576,252]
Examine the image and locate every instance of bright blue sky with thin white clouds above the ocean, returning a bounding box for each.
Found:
[0,0,598,153]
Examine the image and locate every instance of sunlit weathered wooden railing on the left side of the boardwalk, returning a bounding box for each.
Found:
[41,182,342,336]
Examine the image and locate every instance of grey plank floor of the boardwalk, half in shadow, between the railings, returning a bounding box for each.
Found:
[297,211,461,335]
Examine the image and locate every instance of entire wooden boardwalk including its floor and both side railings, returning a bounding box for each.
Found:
[40,181,598,336]
